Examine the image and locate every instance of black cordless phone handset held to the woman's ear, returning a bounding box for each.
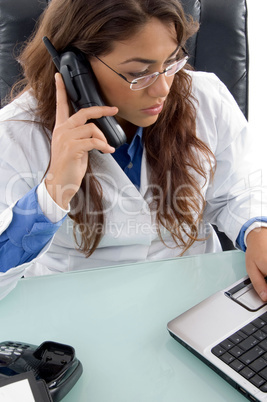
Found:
[43,36,126,148]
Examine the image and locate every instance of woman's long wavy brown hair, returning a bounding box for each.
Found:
[15,0,216,257]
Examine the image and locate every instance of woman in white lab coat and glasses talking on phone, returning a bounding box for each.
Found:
[0,0,267,300]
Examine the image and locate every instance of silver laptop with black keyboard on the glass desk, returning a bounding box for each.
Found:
[167,276,267,402]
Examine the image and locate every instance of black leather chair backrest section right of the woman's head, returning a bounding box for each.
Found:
[181,0,249,118]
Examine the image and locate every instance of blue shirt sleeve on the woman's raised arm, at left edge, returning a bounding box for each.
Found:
[0,186,65,272]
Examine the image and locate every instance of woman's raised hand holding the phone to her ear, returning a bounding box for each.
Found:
[45,73,118,209]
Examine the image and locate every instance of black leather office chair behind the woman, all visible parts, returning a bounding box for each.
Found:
[0,0,248,250]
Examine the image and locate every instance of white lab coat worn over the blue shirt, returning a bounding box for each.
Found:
[0,72,267,298]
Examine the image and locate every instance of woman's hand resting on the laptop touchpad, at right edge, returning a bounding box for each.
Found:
[246,227,267,301]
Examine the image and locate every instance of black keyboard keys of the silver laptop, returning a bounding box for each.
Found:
[211,312,267,392]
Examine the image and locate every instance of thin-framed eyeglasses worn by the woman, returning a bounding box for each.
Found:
[94,48,189,91]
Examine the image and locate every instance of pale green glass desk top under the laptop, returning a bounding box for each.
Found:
[0,251,249,402]
